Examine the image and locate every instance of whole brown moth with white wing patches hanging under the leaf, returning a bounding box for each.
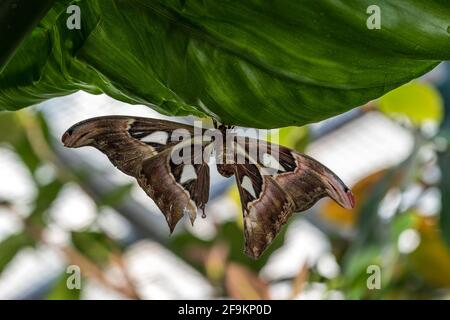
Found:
[62,116,354,258]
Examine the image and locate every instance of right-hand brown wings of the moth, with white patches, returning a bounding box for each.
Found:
[218,139,354,258]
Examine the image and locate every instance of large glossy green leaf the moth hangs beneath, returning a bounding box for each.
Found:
[0,0,450,128]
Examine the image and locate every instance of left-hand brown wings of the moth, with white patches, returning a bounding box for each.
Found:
[62,116,209,232]
